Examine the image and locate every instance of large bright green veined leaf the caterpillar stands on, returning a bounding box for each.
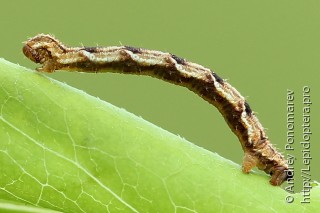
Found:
[0,59,320,212]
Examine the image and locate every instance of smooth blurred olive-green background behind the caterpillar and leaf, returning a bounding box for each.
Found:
[0,0,320,191]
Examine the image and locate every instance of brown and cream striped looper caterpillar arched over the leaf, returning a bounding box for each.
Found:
[23,34,289,186]
